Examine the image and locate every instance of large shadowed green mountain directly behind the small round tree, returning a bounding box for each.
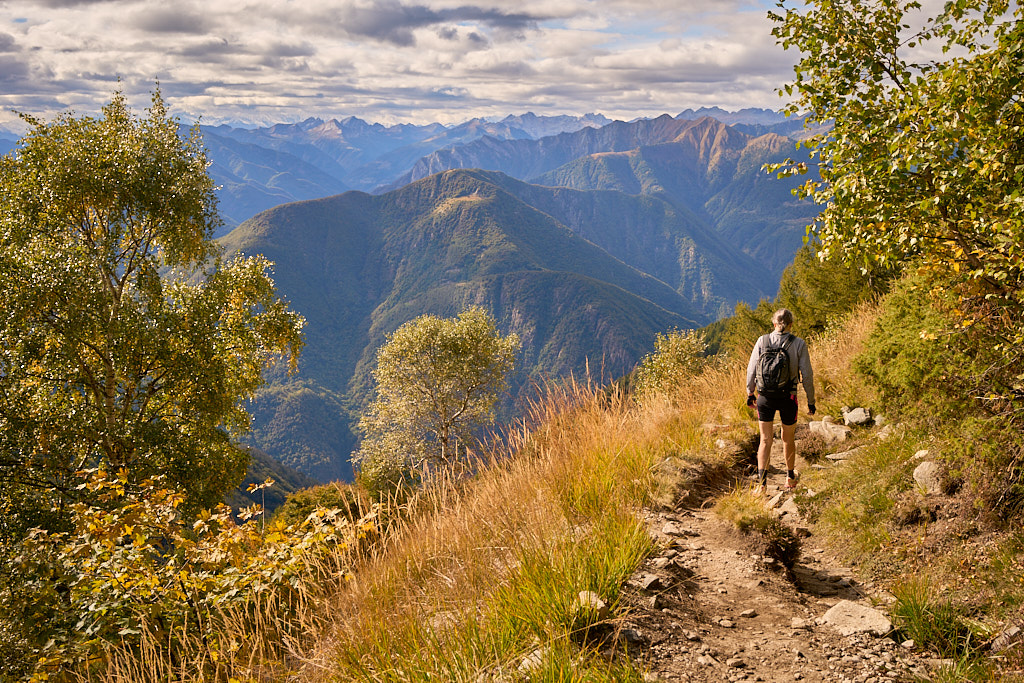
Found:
[222,170,777,479]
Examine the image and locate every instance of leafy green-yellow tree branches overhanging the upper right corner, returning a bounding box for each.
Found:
[773,0,1024,385]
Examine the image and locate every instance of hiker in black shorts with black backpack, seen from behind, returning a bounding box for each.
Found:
[746,308,814,493]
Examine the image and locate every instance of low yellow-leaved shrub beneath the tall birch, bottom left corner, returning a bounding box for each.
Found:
[0,470,376,675]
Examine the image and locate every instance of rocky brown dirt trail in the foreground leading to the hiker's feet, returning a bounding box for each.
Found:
[624,436,924,683]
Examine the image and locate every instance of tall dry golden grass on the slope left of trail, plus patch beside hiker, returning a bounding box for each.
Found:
[79,321,869,681]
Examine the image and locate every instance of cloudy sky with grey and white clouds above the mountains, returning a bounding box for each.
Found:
[0,0,796,126]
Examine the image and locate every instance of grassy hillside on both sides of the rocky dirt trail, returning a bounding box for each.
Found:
[24,274,1024,681]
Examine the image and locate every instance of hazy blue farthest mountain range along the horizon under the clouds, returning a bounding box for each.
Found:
[195,109,801,237]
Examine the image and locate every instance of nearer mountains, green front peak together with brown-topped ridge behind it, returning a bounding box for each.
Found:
[216,116,812,480]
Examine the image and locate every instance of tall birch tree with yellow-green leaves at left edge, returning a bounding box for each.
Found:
[0,92,303,520]
